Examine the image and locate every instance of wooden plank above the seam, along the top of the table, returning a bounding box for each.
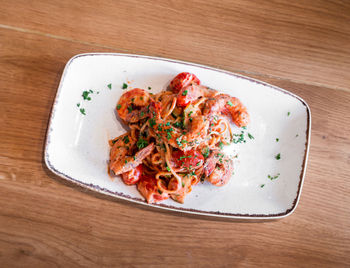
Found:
[0,0,350,90]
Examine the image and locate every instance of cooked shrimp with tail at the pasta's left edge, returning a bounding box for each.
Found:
[109,133,154,175]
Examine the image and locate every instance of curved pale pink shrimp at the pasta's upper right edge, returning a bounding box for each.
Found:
[203,94,249,127]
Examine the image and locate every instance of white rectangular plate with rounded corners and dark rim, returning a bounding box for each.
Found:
[44,53,311,219]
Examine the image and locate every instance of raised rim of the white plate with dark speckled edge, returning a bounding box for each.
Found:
[44,52,311,220]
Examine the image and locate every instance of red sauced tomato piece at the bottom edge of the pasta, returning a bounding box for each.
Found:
[137,175,169,203]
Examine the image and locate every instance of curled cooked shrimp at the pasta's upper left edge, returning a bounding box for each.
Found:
[117,88,150,123]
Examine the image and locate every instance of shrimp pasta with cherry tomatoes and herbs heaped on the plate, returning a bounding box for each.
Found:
[109,72,249,203]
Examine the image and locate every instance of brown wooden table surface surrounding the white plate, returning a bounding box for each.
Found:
[0,0,350,267]
